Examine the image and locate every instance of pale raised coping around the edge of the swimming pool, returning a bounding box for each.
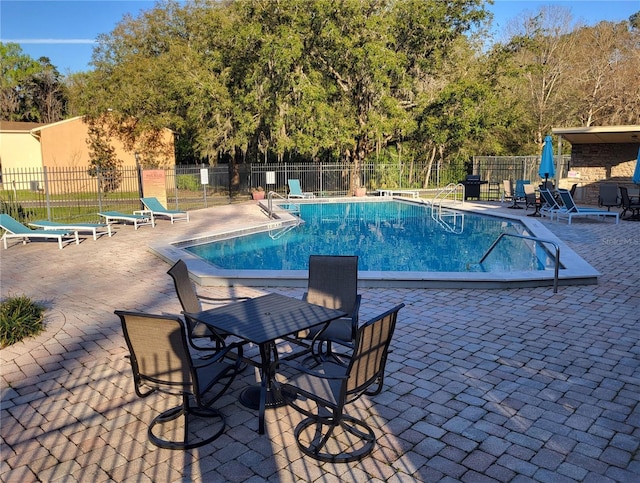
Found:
[149,197,600,289]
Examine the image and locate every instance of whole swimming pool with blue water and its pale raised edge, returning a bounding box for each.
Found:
[151,198,599,288]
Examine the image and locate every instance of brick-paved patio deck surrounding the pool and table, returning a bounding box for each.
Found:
[0,202,640,483]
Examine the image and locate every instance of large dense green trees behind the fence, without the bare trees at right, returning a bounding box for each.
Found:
[76,0,486,180]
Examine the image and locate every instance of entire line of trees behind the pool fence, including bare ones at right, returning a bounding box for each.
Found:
[69,0,640,174]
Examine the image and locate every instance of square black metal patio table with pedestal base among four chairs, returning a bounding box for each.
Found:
[188,294,347,434]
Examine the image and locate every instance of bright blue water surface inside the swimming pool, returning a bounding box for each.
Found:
[185,201,553,272]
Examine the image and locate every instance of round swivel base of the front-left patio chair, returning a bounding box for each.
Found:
[147,394,226,450]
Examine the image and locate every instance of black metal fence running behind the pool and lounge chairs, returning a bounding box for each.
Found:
[0,156,569,222]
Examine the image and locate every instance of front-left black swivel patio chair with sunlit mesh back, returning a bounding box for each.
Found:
[115,310,242,449]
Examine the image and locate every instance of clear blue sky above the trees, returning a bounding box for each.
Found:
[0,0,640,75]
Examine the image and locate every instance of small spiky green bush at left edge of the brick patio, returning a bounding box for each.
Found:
[0,295,45,348]
